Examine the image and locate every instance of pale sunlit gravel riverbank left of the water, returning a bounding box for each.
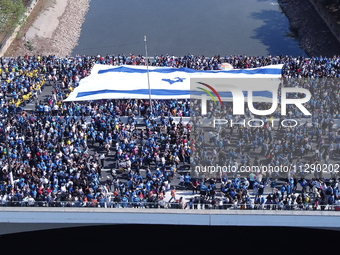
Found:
[5,0,90,57]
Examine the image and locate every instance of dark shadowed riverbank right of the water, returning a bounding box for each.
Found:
[278,0,340,57]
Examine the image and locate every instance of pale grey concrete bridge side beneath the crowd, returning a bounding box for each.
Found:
[0,207,340,234]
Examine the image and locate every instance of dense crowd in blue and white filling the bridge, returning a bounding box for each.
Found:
[0,54,340,208]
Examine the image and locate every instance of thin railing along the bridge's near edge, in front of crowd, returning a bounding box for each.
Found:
[0,200,340,212]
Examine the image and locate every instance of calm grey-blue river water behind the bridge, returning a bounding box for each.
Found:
[72,0,306,56]
